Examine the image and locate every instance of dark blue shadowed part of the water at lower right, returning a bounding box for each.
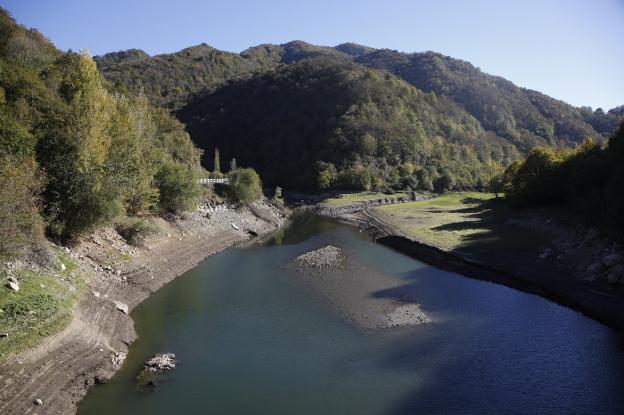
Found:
[371,267,624,415]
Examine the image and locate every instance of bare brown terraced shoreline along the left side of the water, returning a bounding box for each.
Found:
[0,203,285,415]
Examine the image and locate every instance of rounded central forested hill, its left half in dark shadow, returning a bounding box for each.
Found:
[179,57,520,190]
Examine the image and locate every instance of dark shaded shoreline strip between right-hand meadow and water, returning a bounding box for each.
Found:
[332,209,624,332]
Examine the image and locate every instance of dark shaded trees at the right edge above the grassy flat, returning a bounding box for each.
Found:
[490,122,624,235]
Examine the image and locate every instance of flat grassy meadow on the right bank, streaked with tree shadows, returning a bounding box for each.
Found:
[372,192,549,254]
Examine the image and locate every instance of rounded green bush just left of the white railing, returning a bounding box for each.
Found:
[155,160,203,212]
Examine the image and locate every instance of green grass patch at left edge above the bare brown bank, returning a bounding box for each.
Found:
[0,249,86,362]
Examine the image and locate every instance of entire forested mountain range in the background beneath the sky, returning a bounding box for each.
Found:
[96,41,621,189]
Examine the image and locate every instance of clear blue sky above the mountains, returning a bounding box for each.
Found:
[0,0,624,109]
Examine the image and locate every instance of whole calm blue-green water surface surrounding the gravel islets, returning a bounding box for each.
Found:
[79,217,624,415]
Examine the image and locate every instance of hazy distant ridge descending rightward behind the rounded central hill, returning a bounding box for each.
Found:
[355,49,618,151]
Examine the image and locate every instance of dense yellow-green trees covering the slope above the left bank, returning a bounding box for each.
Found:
[0,10,201,256]
